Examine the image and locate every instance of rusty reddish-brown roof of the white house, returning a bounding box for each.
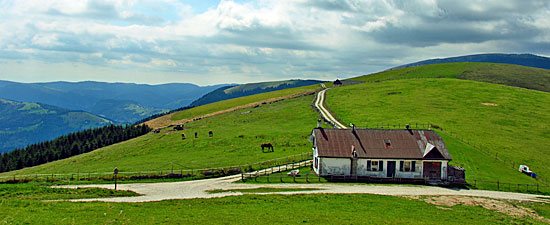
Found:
[313,128,451,160]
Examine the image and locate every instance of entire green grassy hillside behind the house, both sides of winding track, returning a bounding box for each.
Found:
[2,63,550,190]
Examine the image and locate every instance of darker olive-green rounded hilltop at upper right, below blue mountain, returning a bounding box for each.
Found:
[350,63,550,92]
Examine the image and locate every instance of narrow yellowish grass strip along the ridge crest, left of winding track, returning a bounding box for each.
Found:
[171,85,320,120]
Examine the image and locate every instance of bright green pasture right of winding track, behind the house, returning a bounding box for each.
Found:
[326,79,550,185]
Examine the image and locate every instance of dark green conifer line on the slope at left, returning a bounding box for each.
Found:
[0,124,151,172]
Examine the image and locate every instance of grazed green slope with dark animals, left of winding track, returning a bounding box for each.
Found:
[0,95,319,176]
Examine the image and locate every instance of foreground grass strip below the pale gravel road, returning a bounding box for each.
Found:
[0,192,550,224]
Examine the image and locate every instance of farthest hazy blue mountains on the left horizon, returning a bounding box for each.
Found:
[0,81,226,124]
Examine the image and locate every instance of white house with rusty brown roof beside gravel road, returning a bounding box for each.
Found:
[310,128,451,180]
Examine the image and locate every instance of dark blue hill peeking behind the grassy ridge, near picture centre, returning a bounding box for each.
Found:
[190,80,324,106]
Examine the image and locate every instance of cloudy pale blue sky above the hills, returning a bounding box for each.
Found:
[0,0,550,85]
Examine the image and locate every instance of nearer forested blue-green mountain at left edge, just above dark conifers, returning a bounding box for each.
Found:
[0,98,112,152]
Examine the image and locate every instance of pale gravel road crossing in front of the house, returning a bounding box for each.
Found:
[58,175,550,203]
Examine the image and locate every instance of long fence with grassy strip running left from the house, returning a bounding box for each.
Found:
[0,153,312,183]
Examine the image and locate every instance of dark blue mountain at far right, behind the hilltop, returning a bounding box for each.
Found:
[392,53,550,69]
